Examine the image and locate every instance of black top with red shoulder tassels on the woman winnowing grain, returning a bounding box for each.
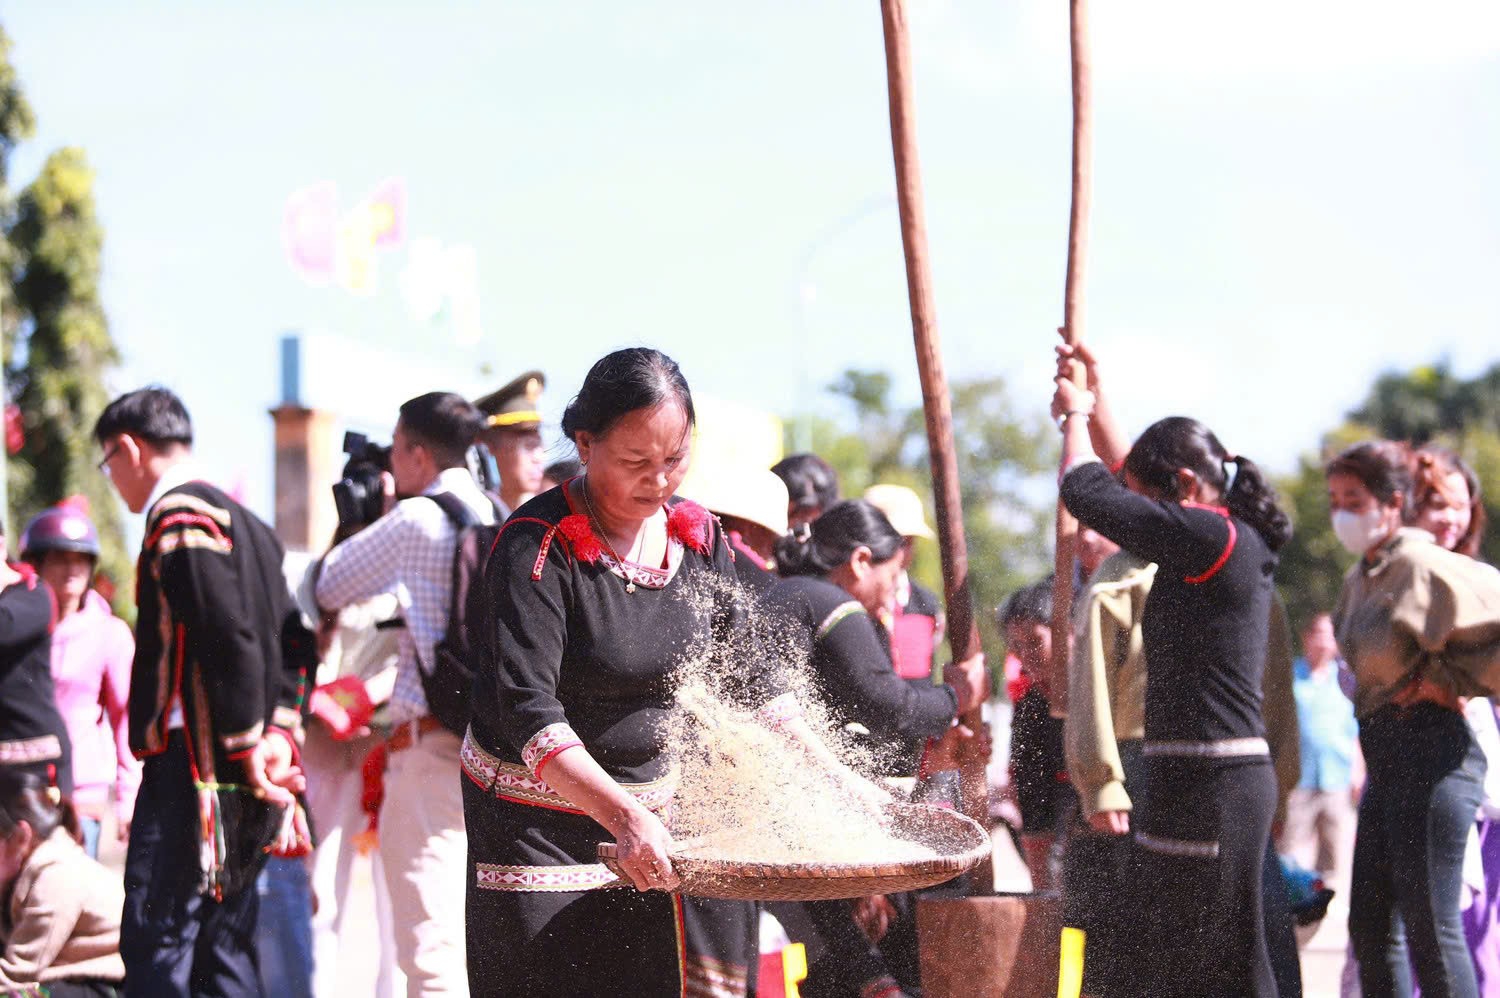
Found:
[471,486,776,783]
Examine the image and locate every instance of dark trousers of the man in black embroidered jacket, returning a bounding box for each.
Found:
[120,731,261,998]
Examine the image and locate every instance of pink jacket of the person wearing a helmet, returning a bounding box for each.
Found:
[53,590,141,821]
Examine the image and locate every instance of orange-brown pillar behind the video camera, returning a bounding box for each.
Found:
[272,404,344,554]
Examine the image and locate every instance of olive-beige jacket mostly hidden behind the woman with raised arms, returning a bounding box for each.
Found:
[1064,551,1302,822]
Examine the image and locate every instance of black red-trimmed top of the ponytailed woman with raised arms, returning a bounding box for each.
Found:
[1062,461,1277,741]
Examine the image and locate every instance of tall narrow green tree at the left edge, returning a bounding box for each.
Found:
[0,25,131,600]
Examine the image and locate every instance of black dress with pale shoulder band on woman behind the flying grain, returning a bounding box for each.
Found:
[762,576,959,998]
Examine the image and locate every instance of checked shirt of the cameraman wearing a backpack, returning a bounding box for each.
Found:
[317,468,495,723]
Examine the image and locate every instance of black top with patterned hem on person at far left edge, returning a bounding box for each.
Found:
[0,564,74,795]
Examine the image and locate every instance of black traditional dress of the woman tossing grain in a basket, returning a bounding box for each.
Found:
[462,486,789,996]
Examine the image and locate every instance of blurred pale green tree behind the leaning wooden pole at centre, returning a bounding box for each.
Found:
[788,371,1058,663]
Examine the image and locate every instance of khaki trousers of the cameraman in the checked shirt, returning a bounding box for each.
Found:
[380,731,468,998]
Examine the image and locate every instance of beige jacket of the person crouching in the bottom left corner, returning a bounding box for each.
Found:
[0,828,125,990]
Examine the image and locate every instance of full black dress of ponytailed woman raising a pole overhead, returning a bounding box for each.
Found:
[1062,461,1277,998]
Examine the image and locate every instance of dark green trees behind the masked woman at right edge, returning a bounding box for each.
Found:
[1277,362,1500,626]
